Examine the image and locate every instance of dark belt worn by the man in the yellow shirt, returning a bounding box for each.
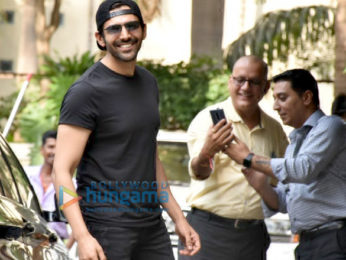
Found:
[191,208,264,229]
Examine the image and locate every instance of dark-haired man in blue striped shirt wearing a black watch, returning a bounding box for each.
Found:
[225,69,346,260]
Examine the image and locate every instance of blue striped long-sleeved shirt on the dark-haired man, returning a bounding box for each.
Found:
[264,110,346,233]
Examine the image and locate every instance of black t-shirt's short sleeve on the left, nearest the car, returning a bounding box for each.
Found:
[59,82,98,130]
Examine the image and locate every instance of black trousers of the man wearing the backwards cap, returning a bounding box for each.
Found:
[87,220,174,260]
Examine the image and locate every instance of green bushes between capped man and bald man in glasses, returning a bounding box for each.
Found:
[140,57,228,130]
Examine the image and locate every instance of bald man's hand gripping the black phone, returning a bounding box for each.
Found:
[202,119,233,157]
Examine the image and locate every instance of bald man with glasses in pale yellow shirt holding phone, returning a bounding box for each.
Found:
[179,56,287,260]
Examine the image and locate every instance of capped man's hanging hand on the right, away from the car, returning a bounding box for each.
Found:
[175,218,201,256]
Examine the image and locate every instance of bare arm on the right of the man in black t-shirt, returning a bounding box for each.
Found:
[156,148,201,256]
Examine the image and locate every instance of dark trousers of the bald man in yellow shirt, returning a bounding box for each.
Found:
[178,211,270,260]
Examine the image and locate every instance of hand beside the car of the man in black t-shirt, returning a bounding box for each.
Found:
[77,233,107,260]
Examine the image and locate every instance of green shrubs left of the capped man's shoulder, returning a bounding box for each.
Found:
[19,52,95,161]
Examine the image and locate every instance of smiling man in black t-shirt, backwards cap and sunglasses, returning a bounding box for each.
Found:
[54,0,200,260]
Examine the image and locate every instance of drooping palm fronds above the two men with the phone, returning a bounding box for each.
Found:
[225,6,335,68]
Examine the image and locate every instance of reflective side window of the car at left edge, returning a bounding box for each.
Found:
[0,137,41,212]
